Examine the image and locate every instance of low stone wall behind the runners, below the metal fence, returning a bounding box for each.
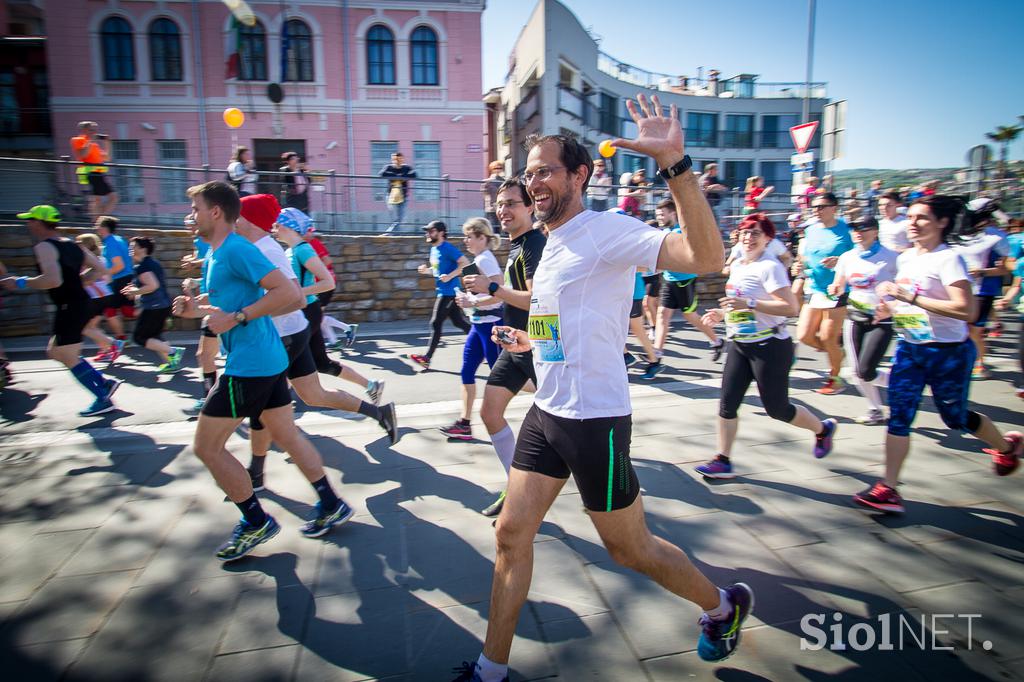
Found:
[0,225,724,337]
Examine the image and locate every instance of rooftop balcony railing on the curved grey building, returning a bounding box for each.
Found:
[597,51,828,99]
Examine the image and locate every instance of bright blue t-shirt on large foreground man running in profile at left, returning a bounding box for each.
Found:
[206,232,288,377]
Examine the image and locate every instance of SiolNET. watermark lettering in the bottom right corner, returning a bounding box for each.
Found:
[800,611,992,651]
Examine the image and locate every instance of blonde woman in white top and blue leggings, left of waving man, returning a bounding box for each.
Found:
[440,218,502,440]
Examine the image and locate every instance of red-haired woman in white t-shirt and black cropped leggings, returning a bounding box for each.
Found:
[696,213,836,478]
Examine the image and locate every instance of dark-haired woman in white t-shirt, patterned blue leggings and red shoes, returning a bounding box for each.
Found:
[853,195,1024,514]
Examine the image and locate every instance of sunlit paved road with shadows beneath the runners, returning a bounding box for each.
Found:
[0,325,1024,682]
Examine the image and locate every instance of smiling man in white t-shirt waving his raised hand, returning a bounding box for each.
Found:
[461,94,754,682]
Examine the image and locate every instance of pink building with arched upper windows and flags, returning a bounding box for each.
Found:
[46,0,489,229]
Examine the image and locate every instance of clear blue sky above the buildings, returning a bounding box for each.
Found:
[483,0,1024,169]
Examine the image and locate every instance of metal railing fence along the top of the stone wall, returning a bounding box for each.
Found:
[0,157,1024,235]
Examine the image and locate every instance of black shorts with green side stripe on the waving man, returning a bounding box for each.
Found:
[512,404,640,512]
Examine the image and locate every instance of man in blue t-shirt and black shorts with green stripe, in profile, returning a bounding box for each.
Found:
[174,182,327,561]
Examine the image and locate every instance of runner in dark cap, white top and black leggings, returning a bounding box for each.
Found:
[828,218,899,424]
